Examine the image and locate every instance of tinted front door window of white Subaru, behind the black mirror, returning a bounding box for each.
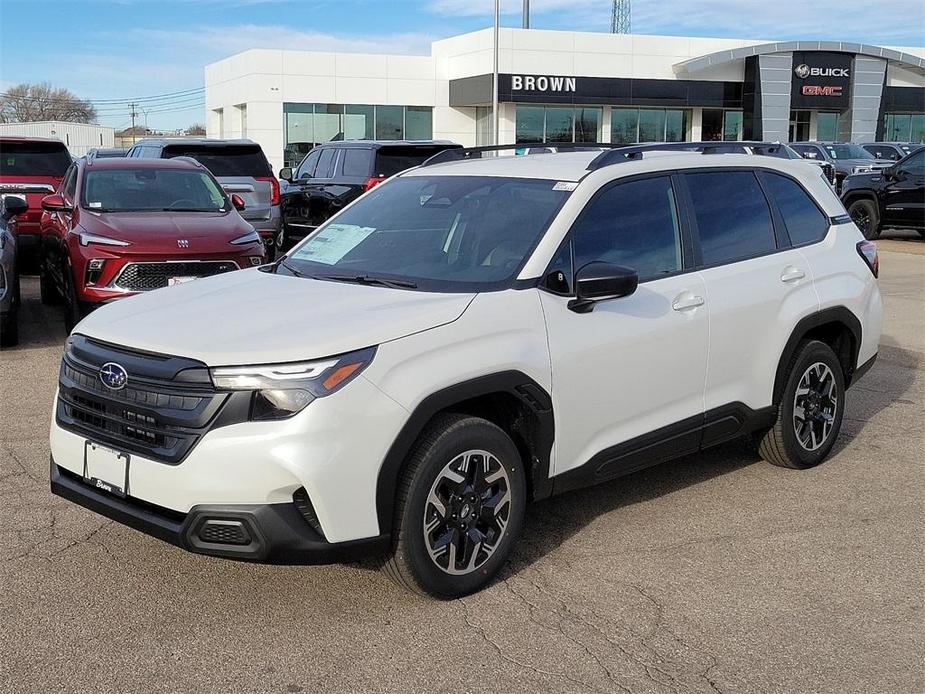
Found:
[572,176,681,281]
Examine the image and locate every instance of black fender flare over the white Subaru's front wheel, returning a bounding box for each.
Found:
[376,371,555,535]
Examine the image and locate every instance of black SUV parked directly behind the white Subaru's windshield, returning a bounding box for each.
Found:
[279,140,462,250]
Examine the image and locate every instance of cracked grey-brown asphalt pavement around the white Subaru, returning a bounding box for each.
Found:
[0,234,925,694]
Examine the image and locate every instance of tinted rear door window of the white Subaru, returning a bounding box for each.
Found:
[685,171,777,266]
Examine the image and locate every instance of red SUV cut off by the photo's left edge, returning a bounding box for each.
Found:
[0,135,71,267]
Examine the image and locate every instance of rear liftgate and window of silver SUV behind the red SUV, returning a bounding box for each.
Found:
[162,143,274,221]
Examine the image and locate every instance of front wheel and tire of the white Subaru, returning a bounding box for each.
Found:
[383,414,527,599]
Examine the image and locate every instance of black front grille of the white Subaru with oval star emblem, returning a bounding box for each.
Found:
[57,336,233,464]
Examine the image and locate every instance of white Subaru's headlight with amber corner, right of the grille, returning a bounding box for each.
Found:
[209,347,376,419]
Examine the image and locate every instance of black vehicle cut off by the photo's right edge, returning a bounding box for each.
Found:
[842,149,925,239]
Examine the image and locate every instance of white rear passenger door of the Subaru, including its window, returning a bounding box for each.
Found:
[683,169,819,416]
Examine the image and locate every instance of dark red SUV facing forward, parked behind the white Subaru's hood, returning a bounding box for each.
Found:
[40,157,264,330]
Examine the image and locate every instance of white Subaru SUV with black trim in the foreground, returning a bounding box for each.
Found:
[51,149,882,598]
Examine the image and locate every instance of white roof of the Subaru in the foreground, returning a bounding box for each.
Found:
[400,151,820,182]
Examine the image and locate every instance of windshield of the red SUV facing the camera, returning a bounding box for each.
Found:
[81,168,228,212]
